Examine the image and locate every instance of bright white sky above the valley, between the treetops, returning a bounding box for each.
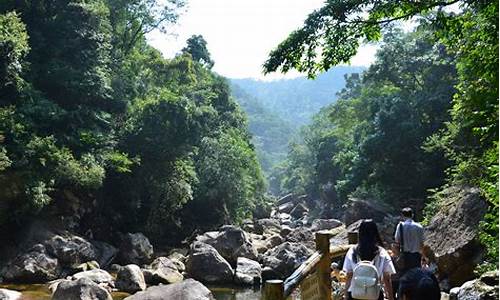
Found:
[148,0,377,80]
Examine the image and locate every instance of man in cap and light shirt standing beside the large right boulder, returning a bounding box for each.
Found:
[394,207,424,276]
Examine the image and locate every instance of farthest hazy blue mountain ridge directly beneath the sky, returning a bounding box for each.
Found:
[230,66,365,129]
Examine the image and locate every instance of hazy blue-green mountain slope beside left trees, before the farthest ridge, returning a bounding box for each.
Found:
[231,83,295,174]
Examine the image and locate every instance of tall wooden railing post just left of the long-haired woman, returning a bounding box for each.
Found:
[316,231,332,300]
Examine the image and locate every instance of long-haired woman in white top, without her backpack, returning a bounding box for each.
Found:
[342,219,396,300]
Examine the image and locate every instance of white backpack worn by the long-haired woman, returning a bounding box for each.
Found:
[351,253,381,300]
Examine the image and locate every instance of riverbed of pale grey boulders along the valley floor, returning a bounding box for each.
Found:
[0,189,498,300]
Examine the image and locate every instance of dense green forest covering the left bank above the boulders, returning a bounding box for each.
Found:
[0,0,265,246]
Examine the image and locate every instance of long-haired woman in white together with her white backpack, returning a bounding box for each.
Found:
[343,220,396,300]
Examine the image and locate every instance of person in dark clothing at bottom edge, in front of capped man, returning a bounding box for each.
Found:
[398,268,441,300]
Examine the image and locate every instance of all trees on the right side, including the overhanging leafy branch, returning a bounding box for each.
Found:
[264,1,498,270]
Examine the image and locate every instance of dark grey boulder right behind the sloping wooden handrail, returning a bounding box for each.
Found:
[263,242,313,279]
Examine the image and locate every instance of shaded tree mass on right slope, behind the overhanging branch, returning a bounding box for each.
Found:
[281,27,455,208]
